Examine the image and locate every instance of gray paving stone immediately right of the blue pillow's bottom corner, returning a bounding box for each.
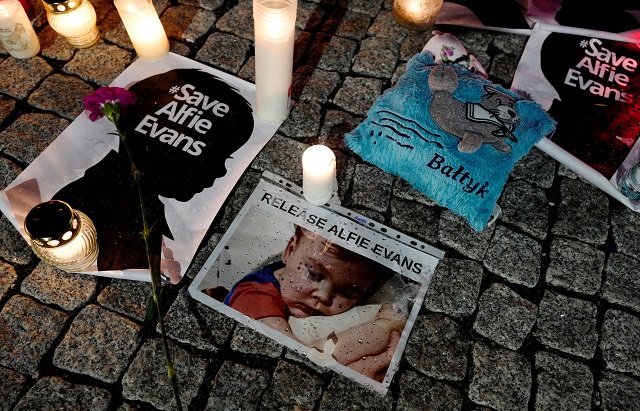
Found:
[498,180,549,240]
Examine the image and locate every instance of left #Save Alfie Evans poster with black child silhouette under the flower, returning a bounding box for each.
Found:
[0,53,280,283]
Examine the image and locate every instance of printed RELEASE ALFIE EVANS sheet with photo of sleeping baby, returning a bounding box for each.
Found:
[190,175,437,390]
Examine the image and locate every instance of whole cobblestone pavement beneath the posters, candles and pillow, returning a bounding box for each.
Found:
[0,0,640,411]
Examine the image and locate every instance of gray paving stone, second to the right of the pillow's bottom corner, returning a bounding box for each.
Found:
[551,178,609,245]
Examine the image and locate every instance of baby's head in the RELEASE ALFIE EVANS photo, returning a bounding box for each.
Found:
[275,234,377,318]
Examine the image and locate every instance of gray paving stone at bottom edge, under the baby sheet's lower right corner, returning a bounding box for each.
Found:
[318,374,393,411]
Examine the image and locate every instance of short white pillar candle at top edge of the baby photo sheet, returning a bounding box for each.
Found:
[302,144,338,205]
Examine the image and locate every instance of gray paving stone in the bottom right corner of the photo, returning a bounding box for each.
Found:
[598,372,640,411]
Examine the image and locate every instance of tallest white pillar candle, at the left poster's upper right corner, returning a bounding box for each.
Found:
[253,0,297,123]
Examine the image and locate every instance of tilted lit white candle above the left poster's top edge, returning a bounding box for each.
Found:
[114,0,169,60]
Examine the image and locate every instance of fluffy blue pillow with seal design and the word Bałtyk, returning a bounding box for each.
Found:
[345,53,555,231]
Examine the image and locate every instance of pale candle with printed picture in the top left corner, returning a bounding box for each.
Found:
[0,0,40,59]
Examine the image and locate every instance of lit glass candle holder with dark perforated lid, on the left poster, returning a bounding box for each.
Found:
[24,200,98,272]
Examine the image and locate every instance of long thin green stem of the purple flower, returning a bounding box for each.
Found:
[115,129,182,411]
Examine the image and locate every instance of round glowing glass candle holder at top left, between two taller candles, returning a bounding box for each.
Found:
[42,0,100,49]
